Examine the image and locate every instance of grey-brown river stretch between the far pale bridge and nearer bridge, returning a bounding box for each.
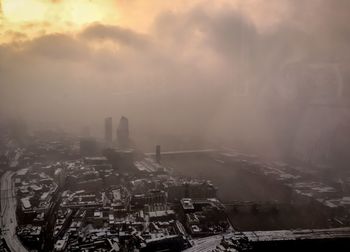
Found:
[162,154,289,202]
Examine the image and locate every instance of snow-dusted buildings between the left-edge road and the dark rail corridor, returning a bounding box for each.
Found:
[13,163,62,248]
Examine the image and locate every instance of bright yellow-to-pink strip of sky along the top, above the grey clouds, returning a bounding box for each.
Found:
[2,0,290,40]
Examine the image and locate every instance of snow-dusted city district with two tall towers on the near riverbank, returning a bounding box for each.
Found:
[6,117,230,251]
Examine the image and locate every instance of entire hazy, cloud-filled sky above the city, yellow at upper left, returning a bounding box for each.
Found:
[0,0,350,158]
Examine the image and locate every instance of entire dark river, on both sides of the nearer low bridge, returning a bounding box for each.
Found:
[162,154,334,231]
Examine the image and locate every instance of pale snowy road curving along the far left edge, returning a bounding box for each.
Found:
[0,171,28,252]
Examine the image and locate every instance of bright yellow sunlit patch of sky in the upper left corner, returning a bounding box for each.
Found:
[0,0,120,43]
